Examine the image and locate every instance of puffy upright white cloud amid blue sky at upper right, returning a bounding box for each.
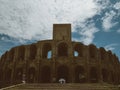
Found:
[102,11,117,32]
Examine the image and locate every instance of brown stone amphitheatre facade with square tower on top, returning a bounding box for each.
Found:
[0,24,120,84]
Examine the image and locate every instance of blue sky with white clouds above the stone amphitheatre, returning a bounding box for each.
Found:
[0,0,120,58]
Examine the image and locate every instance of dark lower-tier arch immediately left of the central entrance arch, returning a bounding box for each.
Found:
[41,66,51,83]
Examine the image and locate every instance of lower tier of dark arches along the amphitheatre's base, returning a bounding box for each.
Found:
[0,65,120,84]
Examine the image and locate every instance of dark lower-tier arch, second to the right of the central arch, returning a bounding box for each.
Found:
[90,67,98,83]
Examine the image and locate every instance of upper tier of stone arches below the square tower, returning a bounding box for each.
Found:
[1,41,119,63]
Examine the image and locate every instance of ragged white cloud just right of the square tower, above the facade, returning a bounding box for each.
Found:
[74,22,99,45]
